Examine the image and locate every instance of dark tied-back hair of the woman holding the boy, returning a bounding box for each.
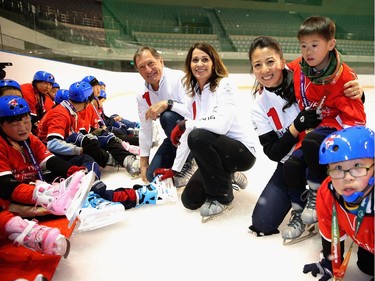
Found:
[248,36,296,111]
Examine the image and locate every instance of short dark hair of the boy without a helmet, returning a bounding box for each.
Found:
[297,16,336,41]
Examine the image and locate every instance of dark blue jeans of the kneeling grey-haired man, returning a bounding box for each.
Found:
[146,110,184,182]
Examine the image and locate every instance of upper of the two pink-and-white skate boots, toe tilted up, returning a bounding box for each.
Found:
[33,171,85,215]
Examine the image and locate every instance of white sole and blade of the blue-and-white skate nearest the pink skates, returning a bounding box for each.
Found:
[74,210,127,234]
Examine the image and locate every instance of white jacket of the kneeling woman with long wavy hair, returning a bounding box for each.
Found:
[172,78,256,172]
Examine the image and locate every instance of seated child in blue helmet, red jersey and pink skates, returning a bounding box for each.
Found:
[0,95,95,256]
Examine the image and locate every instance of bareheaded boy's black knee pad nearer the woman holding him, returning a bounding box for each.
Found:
[283,156,306,189]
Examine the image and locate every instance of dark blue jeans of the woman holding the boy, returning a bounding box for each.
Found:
[251,163,306,235]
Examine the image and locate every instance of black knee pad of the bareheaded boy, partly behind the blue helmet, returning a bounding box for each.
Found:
[302,132,327,182]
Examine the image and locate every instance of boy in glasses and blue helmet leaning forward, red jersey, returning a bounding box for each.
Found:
[303,126,374,281]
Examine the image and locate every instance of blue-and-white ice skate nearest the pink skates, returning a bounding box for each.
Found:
[75,191,126,233]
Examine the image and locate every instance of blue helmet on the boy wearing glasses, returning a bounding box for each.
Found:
[319,126,374,164]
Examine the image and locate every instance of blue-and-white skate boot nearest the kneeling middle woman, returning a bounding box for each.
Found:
[136,175,177,206]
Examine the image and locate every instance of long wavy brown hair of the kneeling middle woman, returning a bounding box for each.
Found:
[183,42,228,95]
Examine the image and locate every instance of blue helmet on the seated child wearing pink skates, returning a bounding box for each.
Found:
[0,96,30,117]
